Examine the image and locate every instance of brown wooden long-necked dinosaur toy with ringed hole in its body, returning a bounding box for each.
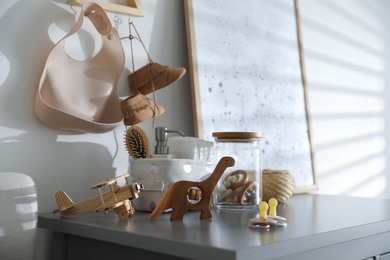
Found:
[149,157,234,220]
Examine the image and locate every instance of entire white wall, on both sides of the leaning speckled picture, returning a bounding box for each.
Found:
[0,0,390,259]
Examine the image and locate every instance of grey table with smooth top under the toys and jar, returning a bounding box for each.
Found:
[38,194,390,260]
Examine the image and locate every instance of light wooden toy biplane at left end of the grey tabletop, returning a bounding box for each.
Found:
[53,173,144,219]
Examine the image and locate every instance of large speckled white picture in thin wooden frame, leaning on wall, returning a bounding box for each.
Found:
[185,0,318,193]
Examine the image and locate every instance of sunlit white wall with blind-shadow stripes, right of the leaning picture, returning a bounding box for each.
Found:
[299,0,390,198]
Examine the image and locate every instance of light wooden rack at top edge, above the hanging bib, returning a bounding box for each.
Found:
[67,0,145,16]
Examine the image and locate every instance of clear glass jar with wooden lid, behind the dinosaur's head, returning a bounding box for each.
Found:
[213,132,263,210]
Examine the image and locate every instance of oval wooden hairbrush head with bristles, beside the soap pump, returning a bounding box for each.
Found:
[125,126,150,159]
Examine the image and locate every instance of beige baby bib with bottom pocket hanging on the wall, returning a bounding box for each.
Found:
[35,3,125,133]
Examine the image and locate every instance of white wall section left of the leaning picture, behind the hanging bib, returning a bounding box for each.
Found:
[0,0,194,259]
